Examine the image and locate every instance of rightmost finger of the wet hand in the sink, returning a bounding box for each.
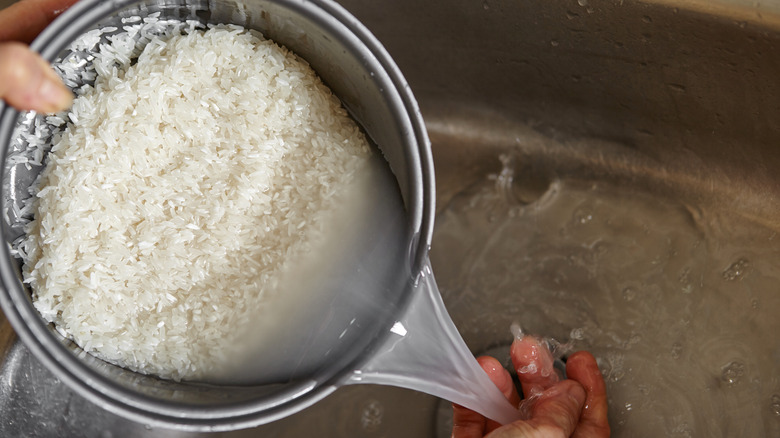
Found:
[566,351,610,438]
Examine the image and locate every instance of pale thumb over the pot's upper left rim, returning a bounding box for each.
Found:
[0,42,73,113]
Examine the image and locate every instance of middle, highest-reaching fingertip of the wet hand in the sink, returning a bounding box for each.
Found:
[510,336,560,398]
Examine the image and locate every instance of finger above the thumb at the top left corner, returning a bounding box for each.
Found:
[0,0,76,43]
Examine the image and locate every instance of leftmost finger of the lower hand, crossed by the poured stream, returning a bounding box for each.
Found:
[452,356,520,438]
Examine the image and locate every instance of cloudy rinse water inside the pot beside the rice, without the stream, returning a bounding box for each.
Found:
[200,150,410,384]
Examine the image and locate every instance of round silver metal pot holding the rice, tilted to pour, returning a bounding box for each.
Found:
[0,0,434,430]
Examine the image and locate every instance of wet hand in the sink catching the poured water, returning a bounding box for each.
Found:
[452,336,610,438]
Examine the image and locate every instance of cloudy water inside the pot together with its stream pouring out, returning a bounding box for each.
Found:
[209,145,520,423]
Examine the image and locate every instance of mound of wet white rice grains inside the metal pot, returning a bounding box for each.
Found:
[16,25,370,380]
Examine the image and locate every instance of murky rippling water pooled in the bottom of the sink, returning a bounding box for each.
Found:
[431,157,780,437]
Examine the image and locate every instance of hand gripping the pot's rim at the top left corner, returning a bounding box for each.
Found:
[0,0,76,113]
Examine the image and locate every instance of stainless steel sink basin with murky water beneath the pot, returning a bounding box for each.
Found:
[0,0,780,437]
